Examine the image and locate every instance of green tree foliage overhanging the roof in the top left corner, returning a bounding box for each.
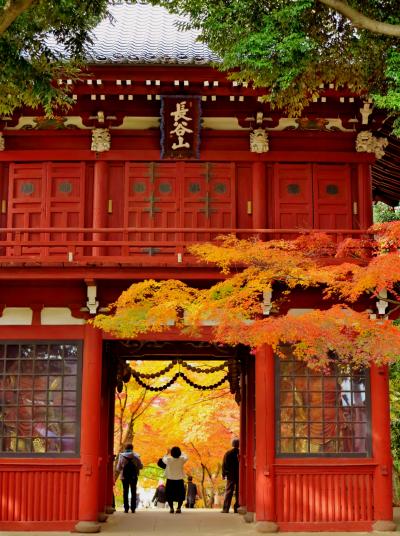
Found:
[0,0,110,115]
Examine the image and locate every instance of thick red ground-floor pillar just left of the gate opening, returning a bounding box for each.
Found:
[75,325,102,532]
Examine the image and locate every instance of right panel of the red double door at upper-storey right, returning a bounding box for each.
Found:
[313,164,352,229]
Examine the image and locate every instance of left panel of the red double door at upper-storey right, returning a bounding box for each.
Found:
[274,164,313,231]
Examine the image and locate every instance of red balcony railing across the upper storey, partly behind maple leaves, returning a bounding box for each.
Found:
[0,227,369,266]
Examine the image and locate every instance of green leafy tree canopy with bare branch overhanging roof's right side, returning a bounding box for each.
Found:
[151,0,400,132]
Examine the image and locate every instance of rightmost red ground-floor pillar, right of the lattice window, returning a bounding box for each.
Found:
[370,365,396,530]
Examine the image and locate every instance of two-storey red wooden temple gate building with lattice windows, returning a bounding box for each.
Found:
[0,6,393,531]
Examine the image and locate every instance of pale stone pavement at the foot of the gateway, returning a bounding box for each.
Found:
[0,508,400,536]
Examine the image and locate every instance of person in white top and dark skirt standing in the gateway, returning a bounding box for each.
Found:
[162,447,188,514]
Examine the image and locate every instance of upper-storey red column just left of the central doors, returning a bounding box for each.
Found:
[93,160,108,256]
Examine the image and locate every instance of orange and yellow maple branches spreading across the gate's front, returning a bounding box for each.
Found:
[94,222,400,368]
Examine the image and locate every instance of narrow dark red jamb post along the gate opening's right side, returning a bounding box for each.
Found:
[246,360,256,513]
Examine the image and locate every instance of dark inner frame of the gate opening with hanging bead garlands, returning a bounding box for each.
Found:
[99,340,255,513]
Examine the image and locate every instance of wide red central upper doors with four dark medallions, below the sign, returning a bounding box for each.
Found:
[124,162,236,246]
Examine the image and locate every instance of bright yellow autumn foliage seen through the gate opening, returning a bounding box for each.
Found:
[109,342,247,511]
